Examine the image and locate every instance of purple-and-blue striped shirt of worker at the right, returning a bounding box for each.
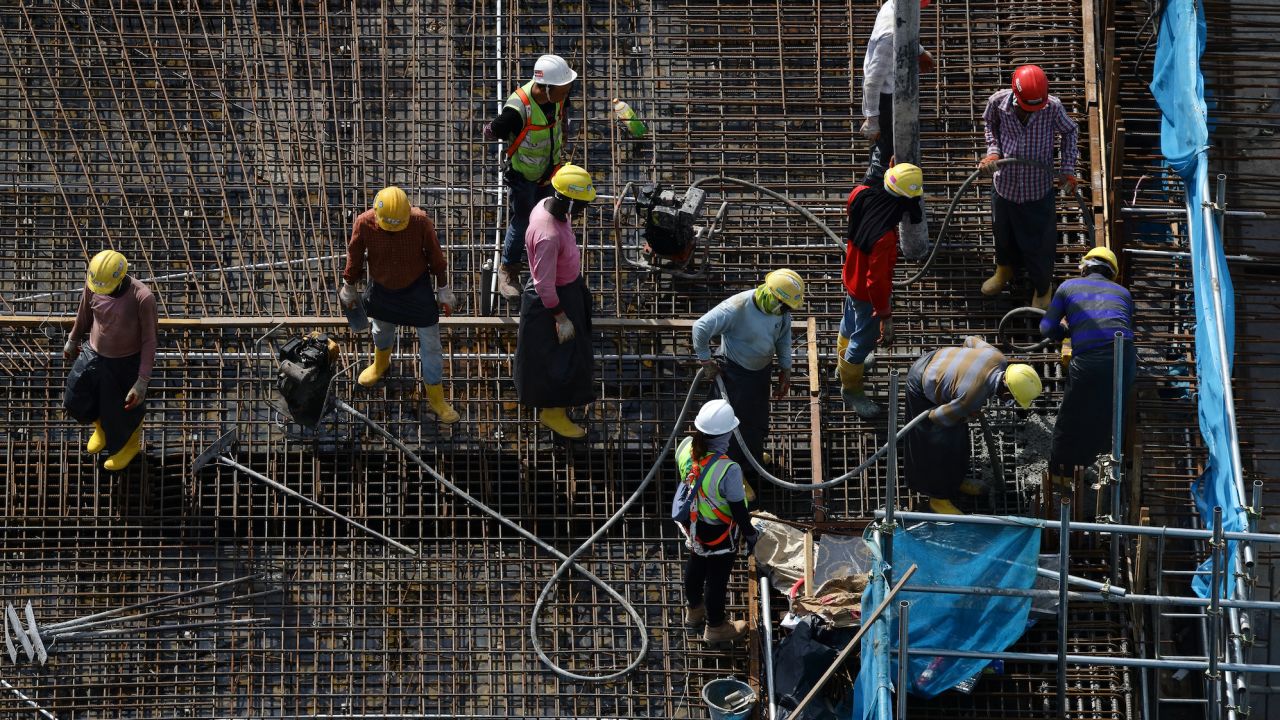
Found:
[1041,273,1133,355]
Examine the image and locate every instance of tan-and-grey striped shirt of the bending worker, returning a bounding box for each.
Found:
[906,336,1007,428]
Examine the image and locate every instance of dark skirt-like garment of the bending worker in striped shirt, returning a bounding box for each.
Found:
[905,384,972,500]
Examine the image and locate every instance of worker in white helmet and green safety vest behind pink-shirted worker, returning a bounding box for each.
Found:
[484,55,577,300]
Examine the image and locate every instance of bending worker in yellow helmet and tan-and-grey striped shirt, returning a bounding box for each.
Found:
[905,336,1041,515]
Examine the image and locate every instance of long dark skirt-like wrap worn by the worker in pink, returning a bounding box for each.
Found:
[515,277,595,407]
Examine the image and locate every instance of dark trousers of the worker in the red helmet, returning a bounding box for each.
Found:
[991,190,1057,295]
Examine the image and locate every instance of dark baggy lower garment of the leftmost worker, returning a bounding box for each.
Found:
[63,345,146,455]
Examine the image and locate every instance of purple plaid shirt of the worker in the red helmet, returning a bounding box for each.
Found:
[982,90,1079,202]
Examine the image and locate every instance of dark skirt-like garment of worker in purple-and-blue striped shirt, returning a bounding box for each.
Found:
[1050,342,1138,470]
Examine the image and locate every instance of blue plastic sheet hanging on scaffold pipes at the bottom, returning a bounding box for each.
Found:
[852,523,1041,720]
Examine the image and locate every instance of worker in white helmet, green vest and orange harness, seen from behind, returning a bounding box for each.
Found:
[676,400,760,647]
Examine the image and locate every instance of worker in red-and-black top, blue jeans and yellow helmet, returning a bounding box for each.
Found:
[836,163,924,418]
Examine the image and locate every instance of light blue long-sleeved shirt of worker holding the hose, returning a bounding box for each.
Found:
[694,288,791,370]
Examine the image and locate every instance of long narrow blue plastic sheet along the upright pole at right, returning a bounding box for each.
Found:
[1151,0,1248,597]
